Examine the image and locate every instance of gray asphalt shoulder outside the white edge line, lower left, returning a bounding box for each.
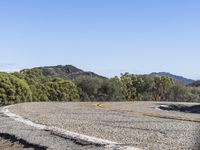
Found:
[0,108,105,150]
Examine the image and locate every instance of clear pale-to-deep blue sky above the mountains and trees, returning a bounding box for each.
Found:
[0,0,200,79]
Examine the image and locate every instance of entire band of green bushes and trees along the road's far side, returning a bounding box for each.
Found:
[0,69,200,105]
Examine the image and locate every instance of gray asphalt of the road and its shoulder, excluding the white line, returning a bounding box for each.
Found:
[0,102,200,150]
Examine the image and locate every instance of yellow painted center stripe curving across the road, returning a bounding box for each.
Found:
[95,104,200,122]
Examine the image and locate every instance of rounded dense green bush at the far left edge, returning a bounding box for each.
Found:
[0,73,32,105]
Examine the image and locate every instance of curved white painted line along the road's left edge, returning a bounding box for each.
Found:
[1,105,139,150]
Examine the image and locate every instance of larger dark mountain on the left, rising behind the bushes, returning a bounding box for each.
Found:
[37,65,106,79]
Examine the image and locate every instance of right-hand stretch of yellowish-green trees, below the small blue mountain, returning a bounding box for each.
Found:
[120,73,200,102]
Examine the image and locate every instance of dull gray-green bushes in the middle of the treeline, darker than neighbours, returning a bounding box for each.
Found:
[75,76,125,101]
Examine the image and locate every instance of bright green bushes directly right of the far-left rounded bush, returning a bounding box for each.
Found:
[14,69,79,101]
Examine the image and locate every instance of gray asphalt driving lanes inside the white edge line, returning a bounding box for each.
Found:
[7,102,200,150]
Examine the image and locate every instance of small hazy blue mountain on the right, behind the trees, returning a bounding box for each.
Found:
[149,72,194,84]
